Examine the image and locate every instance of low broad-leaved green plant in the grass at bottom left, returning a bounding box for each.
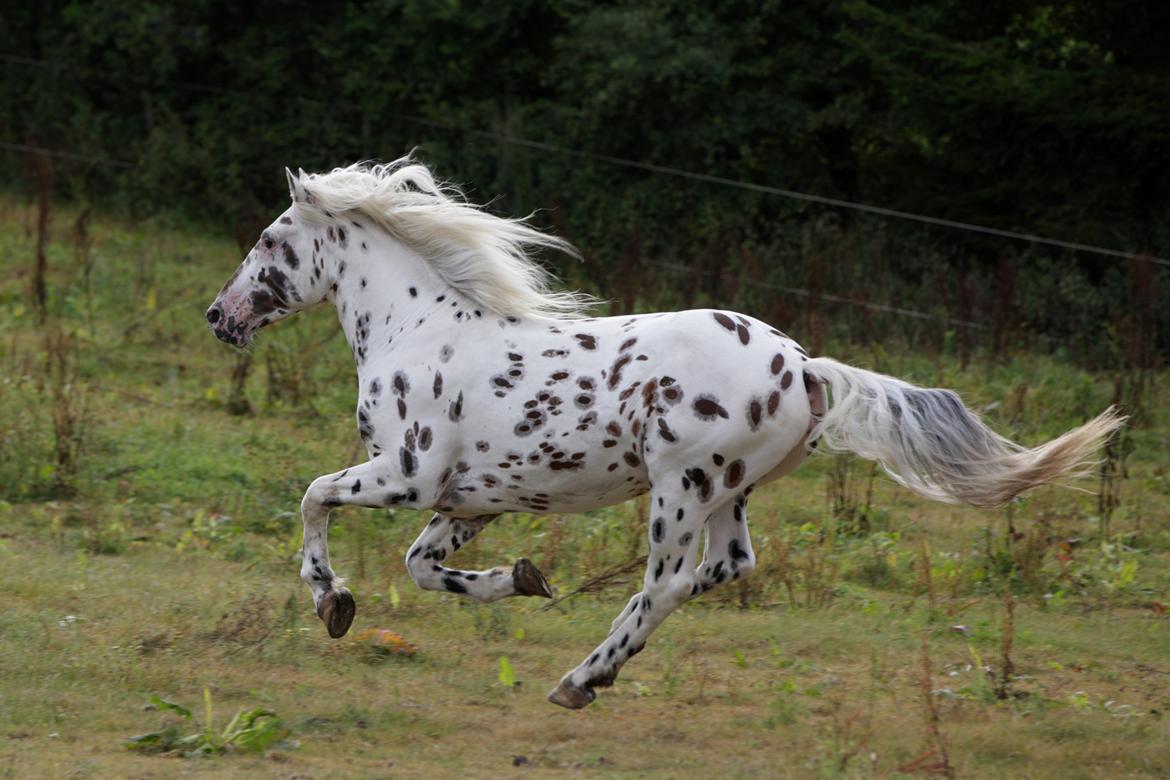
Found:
[126,688,291,758]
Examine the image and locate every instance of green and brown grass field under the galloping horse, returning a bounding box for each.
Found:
[0,200,1170,779]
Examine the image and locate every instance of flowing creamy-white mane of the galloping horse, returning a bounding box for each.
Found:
[295,154,594,318]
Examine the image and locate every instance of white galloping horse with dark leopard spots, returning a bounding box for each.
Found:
[206,156,1123,709]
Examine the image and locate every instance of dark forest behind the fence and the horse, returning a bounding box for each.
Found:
[0,0,1170,367]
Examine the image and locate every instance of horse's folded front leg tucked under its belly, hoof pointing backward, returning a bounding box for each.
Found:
[406,515,552,601]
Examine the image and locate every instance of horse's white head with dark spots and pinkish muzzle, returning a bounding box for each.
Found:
[207,170,328,346]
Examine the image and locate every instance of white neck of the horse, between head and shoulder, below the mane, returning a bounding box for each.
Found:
[330,230,462,377]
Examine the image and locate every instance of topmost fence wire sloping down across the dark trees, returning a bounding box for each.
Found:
[0,54,1170,267]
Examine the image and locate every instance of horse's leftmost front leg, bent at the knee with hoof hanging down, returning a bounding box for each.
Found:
[301,461,419,639]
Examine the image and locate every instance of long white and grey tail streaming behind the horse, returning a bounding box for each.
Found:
[804,358,1126,508]
